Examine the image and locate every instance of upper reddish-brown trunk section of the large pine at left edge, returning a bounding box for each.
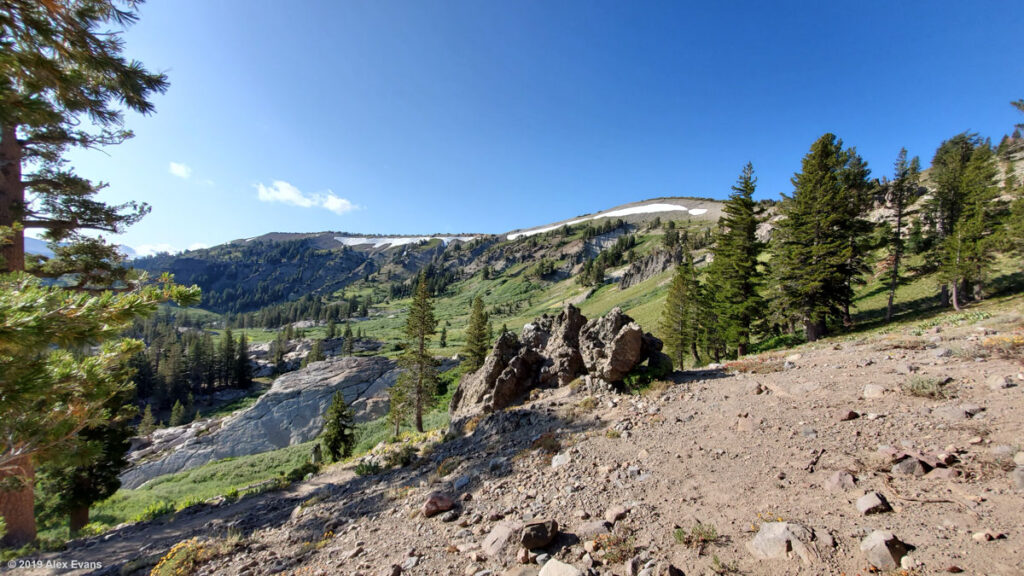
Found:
[0,125,25,272]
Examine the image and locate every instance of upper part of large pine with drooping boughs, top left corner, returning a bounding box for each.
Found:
[0,0,168,278]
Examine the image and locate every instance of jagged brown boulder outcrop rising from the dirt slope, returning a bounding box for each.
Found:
[450,304,671,429]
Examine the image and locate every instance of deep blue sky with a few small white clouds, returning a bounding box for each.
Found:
[59,0,1024,252]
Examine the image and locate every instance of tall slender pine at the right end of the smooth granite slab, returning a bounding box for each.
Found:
[392,273,437,433]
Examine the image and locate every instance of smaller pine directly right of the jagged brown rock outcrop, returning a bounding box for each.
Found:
[662,250,700,369]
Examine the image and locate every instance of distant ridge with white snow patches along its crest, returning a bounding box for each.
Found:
[133,198,722,313]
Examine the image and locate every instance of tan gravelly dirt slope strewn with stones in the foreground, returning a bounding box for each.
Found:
[16,303,1024,576]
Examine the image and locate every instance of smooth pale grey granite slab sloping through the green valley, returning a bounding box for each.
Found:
[121,357,398,488]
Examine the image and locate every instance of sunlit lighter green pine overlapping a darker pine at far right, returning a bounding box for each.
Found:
[939,141,997,311]
